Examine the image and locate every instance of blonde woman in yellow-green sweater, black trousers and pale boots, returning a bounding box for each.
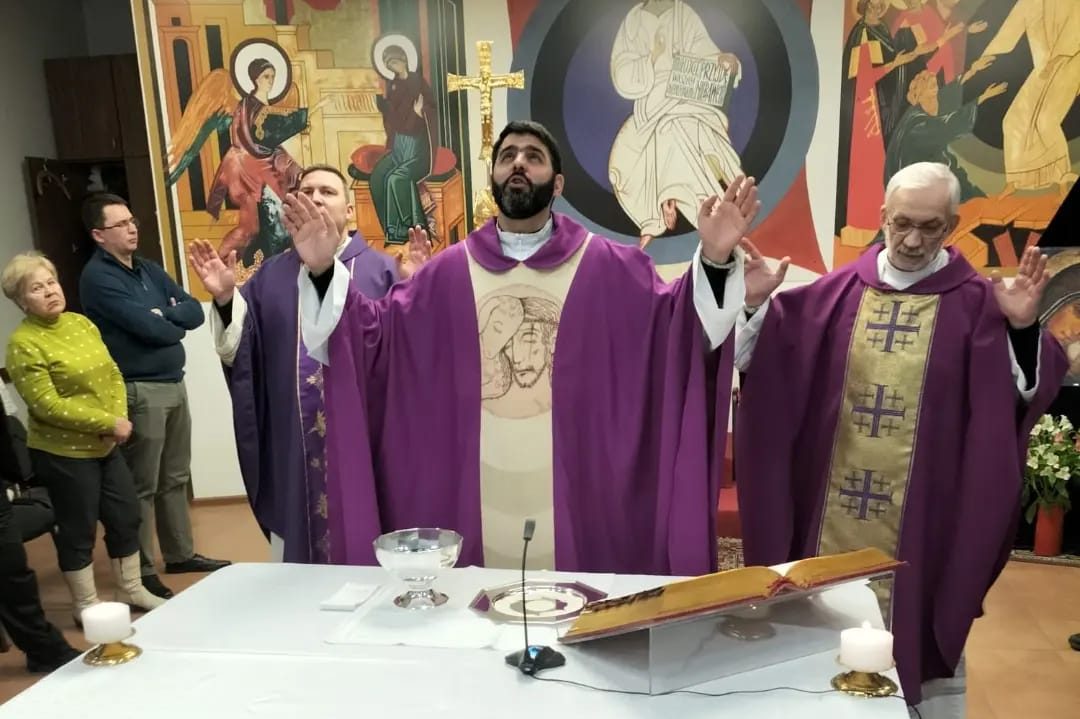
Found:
[0,254,164,622]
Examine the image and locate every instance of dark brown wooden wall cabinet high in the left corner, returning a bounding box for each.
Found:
[45,55,149,160]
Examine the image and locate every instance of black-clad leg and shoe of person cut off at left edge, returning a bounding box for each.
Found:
[0,492,71,664]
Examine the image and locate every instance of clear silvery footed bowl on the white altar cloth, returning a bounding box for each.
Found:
[375,528,461,609]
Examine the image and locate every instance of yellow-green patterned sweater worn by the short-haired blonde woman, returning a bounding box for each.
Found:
[6,312,127,458]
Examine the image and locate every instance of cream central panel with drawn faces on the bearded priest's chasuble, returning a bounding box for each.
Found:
[469,234,592,569]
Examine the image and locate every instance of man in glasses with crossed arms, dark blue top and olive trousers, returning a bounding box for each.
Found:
[79,194,229,599]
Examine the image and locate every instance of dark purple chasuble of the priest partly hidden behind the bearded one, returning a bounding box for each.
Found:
[226,233,397,564]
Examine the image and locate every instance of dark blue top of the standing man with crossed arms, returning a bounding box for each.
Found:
[79,248,206,382]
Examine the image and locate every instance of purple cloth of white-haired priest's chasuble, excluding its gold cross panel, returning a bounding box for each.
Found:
[735,248,1067,704]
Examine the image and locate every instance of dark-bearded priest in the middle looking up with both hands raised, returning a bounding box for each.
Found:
[286,122,760,574]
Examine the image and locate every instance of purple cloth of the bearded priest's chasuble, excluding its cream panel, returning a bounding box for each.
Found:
[324,215,733,574]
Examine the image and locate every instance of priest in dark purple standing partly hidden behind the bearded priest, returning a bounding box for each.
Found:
[185,165,421,564]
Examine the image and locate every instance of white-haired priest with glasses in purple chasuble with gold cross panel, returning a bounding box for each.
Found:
[735,163,1066,718]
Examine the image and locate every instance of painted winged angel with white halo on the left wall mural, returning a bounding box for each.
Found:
[166,39,330,267]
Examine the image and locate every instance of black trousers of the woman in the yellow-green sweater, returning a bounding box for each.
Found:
[30,449,141,572]
